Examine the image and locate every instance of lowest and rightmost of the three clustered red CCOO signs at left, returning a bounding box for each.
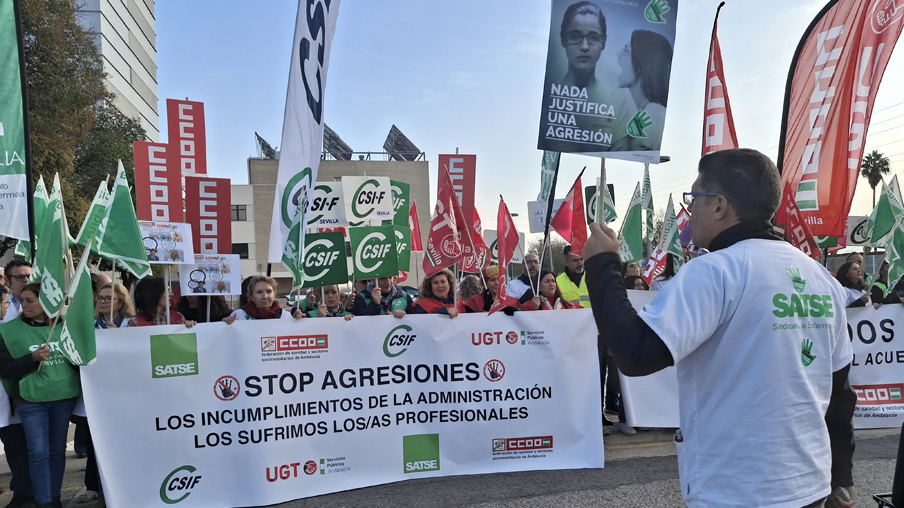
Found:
[185,177,232,254]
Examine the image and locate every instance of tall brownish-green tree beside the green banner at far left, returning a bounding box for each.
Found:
[21,0,112,227]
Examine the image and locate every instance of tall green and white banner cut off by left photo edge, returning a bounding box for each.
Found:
[0,1,30,240]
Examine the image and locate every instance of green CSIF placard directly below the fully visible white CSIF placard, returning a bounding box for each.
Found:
[348,226,399,280]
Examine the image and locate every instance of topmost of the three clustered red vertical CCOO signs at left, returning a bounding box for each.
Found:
[166,99,207,175]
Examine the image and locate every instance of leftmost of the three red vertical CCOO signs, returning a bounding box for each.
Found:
[132,141,183,222]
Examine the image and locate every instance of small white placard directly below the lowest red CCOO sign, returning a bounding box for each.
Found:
[179,254,242,296]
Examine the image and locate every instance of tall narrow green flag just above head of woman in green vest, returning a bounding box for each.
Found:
[35,175,69,317]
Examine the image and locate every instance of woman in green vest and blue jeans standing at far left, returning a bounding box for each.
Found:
[0,283,80,508]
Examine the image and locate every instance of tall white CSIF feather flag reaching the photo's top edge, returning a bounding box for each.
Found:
[268,0,339,266]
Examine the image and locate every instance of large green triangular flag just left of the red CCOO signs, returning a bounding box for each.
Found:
[95,161,151,279]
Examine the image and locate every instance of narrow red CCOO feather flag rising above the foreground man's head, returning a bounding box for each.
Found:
[702,2,738,155]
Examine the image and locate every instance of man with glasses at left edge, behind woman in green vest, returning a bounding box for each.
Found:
[0,259,34,508]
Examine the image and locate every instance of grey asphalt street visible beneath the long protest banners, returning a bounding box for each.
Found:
[0,421,900,508]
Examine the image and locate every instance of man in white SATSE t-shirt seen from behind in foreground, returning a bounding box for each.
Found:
[584,149,856,508]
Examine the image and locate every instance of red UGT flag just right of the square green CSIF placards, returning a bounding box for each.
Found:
[424,170,462,277]
